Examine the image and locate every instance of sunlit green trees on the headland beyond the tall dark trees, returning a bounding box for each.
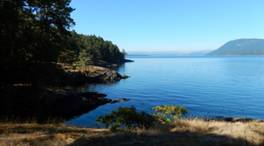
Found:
[58,31,125,66]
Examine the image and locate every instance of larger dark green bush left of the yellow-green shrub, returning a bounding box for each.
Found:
[97,107,156,130]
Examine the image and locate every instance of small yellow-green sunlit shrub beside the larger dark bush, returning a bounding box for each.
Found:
[153,105,187,124]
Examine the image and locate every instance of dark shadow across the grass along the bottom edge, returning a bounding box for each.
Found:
[70,132,262,146]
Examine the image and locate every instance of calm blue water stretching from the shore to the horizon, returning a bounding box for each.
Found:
[67,57,264,127]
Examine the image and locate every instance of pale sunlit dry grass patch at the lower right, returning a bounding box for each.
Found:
[171,119,264,145]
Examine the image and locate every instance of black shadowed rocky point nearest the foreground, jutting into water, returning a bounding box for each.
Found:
[0,86,128,123]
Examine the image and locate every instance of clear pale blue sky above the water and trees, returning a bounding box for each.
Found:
[71,0,264,52]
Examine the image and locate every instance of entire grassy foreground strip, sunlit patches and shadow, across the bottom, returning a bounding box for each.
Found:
[0,119,264,146]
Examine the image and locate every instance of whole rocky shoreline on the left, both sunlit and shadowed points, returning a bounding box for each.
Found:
[0,63,128,123]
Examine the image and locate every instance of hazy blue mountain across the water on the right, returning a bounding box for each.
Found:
[208,39,264,56]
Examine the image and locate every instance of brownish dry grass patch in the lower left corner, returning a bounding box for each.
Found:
[0,123,108,146]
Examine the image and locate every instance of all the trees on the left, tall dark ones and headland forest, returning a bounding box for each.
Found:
[0,0,125,66]
